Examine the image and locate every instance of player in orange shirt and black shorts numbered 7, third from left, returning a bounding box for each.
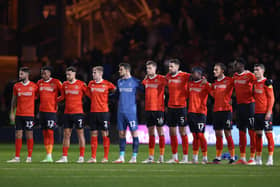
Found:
[56,67,87,163]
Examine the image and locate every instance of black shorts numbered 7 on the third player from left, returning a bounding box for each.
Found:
[63,114,85,129]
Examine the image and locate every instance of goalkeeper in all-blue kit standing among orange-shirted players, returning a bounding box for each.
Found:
[113,63,142,163]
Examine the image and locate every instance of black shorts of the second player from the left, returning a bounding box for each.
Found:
[39,112,56,129]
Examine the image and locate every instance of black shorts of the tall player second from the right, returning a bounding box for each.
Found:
[236,103,255,130]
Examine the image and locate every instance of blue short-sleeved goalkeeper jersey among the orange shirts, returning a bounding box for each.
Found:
[117,77,142,113]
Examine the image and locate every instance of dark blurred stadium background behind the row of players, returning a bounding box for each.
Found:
[0,0,280,141]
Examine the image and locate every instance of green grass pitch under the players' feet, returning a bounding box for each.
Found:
[0,144,280,187]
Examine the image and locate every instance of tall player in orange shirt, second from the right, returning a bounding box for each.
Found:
[233,58,256,165]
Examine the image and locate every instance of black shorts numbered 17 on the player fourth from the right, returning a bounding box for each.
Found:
[188,113,206,133]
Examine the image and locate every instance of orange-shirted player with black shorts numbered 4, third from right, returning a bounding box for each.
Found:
[211,63,235,164]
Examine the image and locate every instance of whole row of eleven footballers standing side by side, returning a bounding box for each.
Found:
[7,58,274,166]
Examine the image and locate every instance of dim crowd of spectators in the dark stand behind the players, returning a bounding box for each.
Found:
[2,0,280,127]
